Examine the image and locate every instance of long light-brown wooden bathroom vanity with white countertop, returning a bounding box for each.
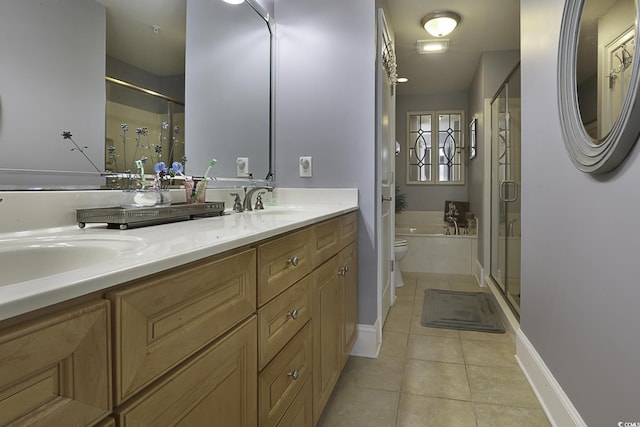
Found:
[0,191,357,427]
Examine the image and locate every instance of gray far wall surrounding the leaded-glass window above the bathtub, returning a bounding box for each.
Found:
[396,92,469,211]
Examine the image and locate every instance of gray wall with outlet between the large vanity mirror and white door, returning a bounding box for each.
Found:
[274,0,377,325]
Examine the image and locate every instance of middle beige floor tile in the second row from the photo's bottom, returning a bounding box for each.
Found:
[402,359,471,400]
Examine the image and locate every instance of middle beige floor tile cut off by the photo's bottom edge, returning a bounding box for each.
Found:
[396,394,476,427]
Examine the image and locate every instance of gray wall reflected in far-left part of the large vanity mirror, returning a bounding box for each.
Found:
[0,0,106,186]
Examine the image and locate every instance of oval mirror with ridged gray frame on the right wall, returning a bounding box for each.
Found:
[558,0,640,174]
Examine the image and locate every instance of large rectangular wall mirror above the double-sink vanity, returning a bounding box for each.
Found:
[0,0,274,189]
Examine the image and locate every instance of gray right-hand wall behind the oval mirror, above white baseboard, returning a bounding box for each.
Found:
[521,0,640,426]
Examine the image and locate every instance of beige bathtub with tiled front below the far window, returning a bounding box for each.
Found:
[395,223,478,274]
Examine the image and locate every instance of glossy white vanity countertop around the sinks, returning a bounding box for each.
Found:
[0,191,358,320]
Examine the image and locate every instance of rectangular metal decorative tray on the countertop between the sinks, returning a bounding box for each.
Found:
[76,202,224,230]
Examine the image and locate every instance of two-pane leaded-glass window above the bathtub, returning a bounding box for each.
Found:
[407,111,465,184]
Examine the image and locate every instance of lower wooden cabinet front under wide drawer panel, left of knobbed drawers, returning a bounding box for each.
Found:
[115,316,258,427]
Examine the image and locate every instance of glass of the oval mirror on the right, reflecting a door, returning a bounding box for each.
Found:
[576,0,636,143]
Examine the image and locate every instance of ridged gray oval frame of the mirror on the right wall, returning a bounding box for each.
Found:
[558,0,640,175]
